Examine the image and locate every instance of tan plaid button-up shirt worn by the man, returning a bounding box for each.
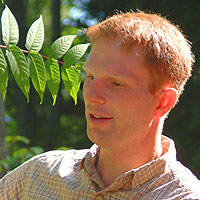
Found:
[0,137,200,200]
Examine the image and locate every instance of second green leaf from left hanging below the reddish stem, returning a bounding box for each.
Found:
[6,45,30,102]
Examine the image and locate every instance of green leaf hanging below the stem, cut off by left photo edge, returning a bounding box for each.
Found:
[0,49,8,100]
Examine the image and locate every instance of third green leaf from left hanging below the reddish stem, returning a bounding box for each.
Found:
[27,51,46,103]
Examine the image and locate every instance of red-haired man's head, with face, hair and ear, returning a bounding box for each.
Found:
[83,12,193,151]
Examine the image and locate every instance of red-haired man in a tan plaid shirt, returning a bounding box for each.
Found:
[0,12,200,200]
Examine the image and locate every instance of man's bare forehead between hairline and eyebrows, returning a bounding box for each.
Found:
[84,39,147,79]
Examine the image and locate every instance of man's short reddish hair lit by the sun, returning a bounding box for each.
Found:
[86,11,194,95]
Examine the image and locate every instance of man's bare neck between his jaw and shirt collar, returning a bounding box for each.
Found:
[96,123,162,187]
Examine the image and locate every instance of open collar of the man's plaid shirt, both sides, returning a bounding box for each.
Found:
[80,136,176,190]
